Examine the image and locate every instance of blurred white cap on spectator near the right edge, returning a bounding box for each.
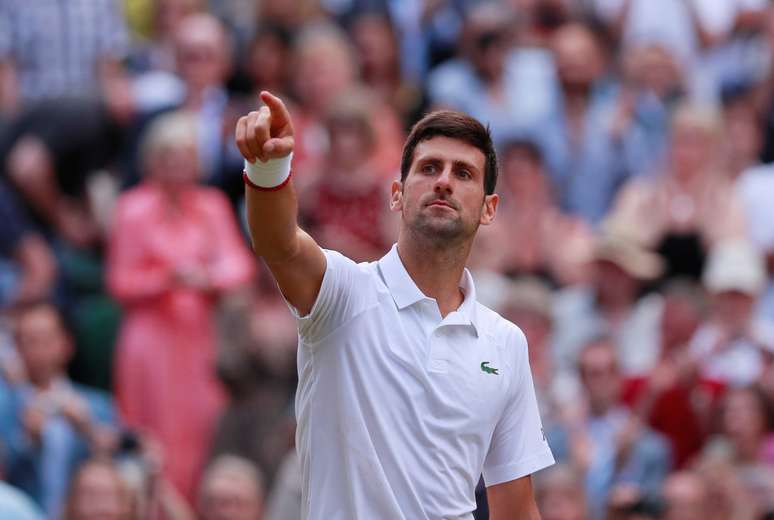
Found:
[702,240,766,296]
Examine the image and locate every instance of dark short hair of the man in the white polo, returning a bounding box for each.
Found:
[400,110,497,195]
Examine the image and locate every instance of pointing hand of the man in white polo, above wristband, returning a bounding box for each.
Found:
[236,90,294,163]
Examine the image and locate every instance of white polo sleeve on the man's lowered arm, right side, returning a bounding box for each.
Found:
[483,329,554,486]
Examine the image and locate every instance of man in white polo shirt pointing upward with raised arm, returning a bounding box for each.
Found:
[236,91,553,520]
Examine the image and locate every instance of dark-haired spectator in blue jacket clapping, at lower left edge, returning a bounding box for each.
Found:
[0,303,115,518]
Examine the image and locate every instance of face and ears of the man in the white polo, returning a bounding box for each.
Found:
[390,136,498,243]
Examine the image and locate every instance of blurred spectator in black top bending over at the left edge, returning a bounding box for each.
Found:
[0,99,123,247]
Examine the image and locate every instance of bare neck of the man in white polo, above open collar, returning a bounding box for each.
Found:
[398,233,471,317]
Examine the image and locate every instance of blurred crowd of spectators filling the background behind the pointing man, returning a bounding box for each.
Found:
[0,0,774,520]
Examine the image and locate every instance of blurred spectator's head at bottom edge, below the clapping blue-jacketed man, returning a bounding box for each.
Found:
[62,459,132,520]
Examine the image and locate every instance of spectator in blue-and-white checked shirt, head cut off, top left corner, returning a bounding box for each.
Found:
[0,0,131,114]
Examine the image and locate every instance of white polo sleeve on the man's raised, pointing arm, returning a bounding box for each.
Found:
[288,249,374,345]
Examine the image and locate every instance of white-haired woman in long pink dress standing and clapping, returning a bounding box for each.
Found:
[108,113,256,499]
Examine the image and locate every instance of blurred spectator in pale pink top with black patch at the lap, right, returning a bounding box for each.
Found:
[607,105,746,280]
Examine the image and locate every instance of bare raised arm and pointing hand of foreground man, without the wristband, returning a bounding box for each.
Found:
[236,91,325,315]
